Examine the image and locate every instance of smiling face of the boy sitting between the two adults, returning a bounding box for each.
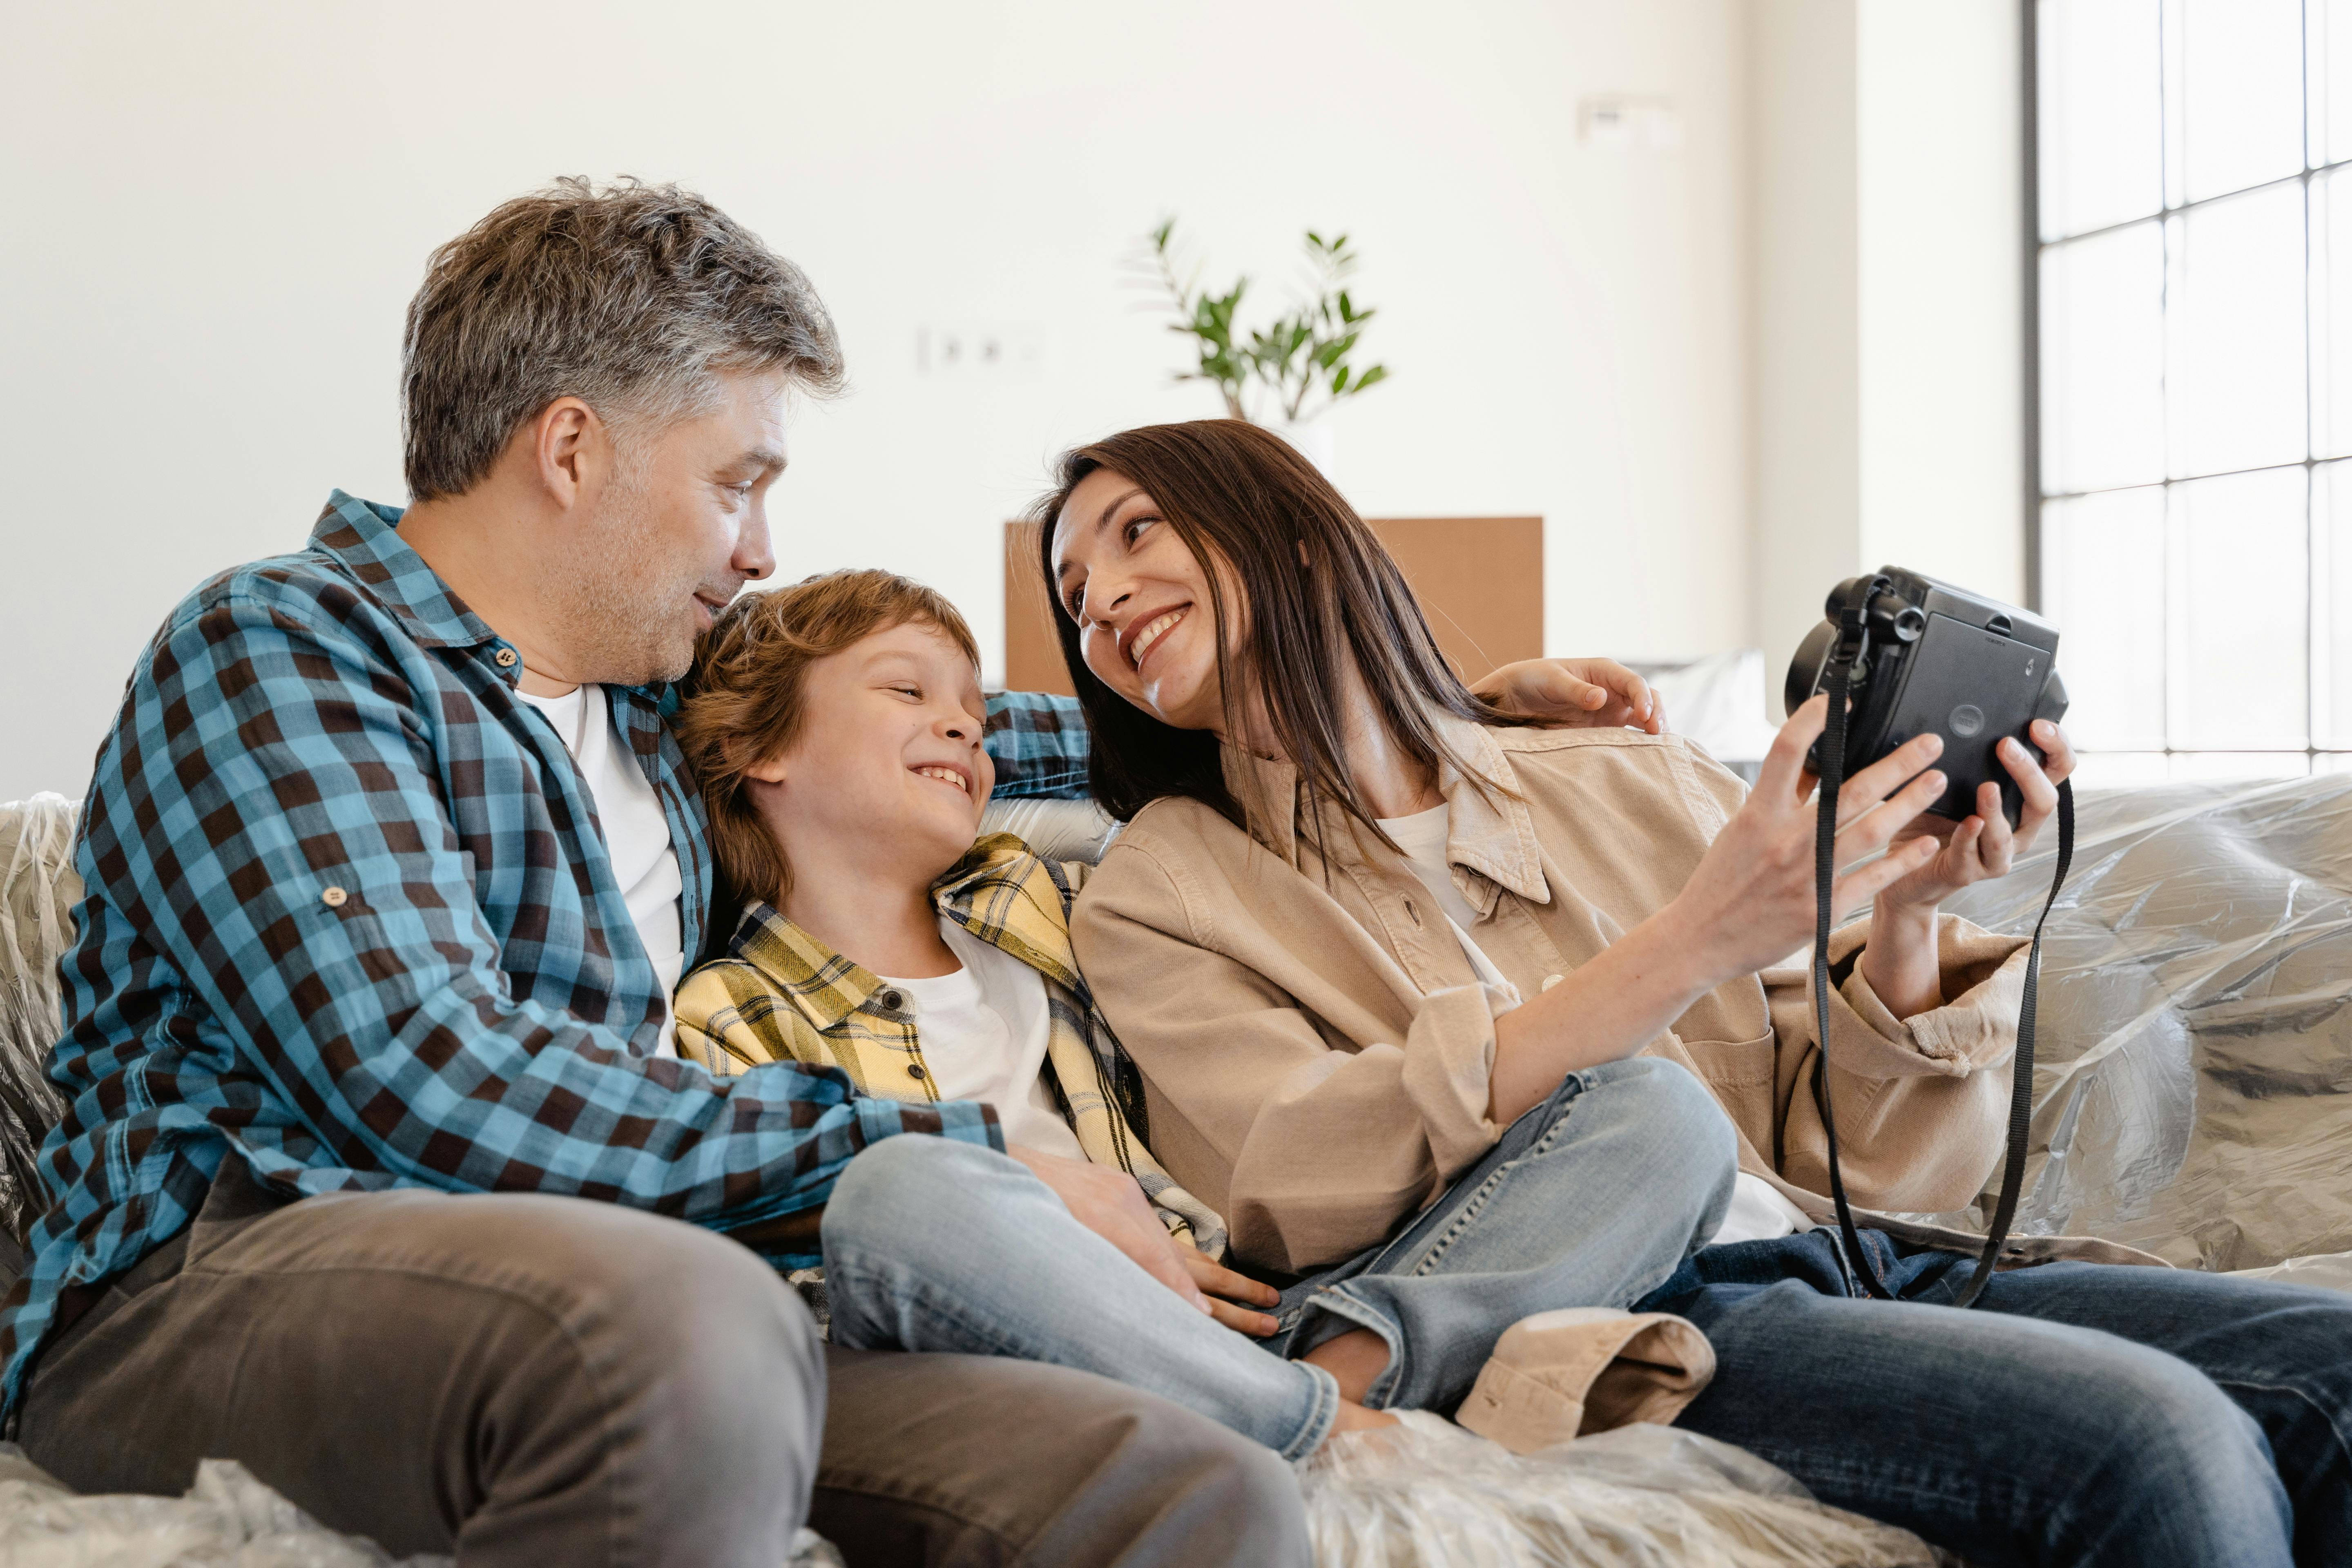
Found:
[745,620,997,886]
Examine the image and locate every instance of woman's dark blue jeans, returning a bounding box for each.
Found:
[1635,1229,2352,1568]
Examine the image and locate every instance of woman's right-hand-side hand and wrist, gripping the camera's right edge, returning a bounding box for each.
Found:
[1861,719,2075,1018]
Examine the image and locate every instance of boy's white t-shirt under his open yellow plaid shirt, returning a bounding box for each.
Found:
[877,917,1087,1159]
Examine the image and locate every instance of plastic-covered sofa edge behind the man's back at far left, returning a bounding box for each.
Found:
[0,794,83,1265]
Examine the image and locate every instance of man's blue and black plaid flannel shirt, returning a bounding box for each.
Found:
[0,491,1087,1422]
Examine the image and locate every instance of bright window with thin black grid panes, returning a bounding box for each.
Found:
[2035,0,2352,785]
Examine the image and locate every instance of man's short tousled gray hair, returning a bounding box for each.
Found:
[400,178,842,501]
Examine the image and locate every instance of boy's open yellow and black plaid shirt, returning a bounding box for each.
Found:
[677,832,1225,1258]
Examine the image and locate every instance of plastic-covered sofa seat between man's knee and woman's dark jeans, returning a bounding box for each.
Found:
[1301,1413,1957,1568]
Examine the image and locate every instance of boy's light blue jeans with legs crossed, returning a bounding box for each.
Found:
[823,1058,1736,1457]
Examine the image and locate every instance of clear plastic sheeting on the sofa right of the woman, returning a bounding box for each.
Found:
[1921,776,2352,1269]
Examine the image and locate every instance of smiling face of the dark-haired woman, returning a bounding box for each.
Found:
[1054,468,1237,731]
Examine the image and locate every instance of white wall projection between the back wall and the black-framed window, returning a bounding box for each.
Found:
[1747,0,2025,707]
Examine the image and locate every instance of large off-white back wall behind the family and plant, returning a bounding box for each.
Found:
[0,0,1759,799]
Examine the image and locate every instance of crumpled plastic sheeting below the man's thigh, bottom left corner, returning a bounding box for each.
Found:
[0,1443,842,1568]
